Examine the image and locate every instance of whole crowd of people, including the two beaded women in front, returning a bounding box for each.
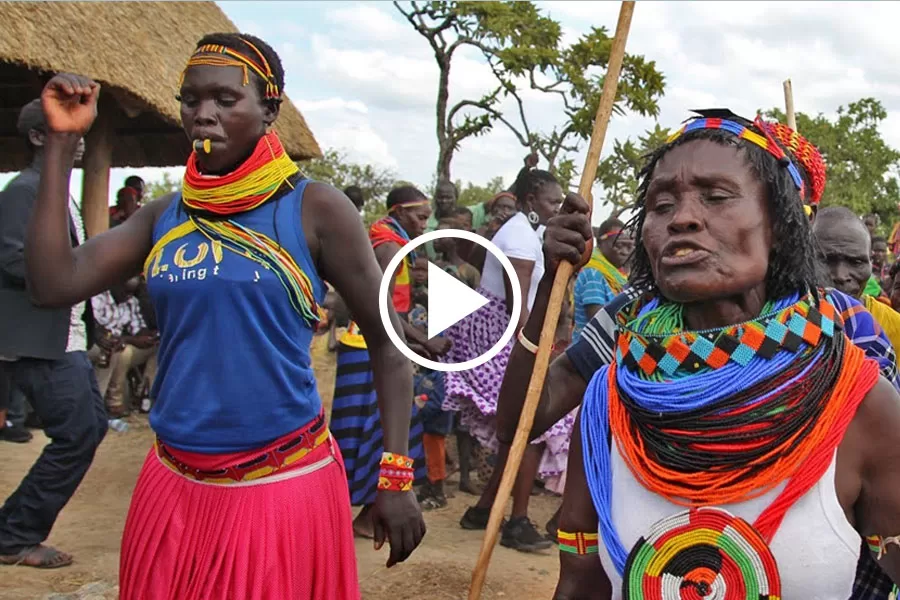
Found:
[0,28,900,600]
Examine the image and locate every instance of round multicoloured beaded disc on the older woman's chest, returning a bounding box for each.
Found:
[622,507,781,600]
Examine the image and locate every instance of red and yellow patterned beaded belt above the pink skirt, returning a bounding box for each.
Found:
[154,414,331,484]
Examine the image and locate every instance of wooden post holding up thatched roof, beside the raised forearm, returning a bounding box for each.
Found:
[81,102,115,238]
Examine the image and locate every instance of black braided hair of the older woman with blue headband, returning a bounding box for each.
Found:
[629,116,825,298]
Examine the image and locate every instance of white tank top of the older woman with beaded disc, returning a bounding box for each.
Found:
[599,444,861,600]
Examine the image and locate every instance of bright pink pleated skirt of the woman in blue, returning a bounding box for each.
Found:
[119,438,360,600]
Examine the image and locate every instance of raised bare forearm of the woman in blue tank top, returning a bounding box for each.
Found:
[25,133,79,304]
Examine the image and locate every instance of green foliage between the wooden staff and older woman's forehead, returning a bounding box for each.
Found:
[597,124,669,215]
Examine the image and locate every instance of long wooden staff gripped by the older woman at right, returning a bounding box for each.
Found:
[469,0,634,600]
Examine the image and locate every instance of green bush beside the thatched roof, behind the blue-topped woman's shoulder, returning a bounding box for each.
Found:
[297,148,398,224]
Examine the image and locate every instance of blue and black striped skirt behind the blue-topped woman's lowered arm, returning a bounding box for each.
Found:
[331,344,426,506]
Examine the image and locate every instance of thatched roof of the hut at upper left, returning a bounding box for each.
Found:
[0,2,321,171]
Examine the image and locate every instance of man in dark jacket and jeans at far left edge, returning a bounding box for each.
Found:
[0,100,107,568]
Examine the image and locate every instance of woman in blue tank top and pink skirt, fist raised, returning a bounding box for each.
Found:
[25,33,425,600]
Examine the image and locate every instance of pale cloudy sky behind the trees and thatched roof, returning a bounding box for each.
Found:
[8,1,900,220]
